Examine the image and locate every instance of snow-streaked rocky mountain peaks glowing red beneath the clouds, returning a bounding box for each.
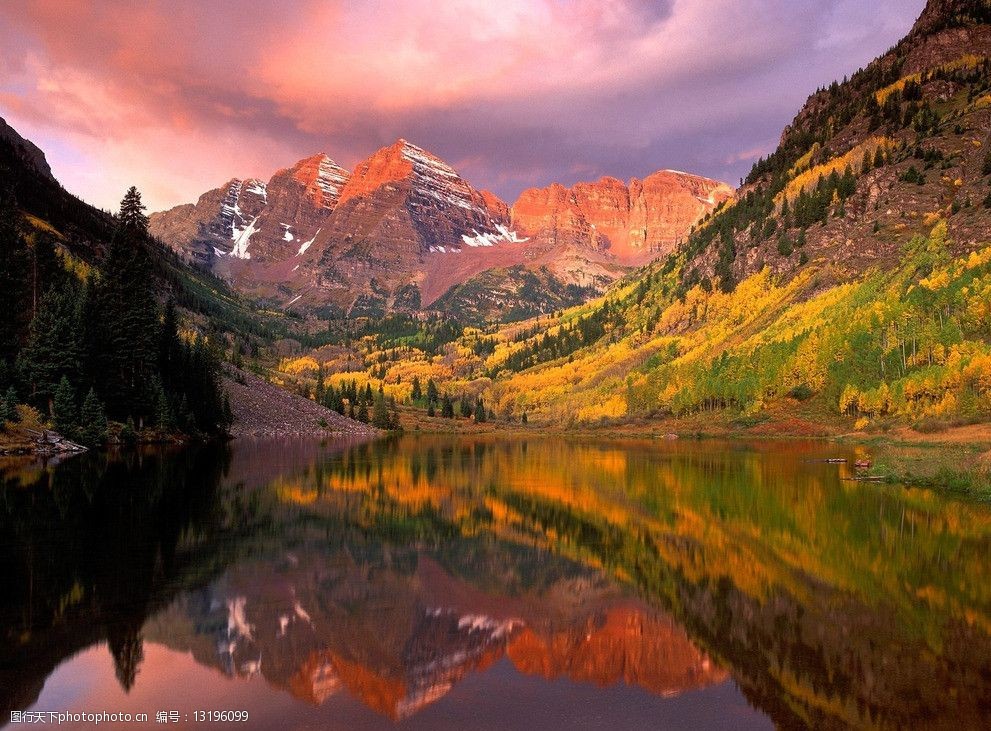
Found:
[151,139,733,319]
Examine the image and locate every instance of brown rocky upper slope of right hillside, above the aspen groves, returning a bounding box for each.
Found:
[682,0,991,291]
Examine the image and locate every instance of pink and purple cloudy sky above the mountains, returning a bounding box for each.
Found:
[0,0,925,210]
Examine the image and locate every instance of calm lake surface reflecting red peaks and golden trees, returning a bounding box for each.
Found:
[0,436,991,729]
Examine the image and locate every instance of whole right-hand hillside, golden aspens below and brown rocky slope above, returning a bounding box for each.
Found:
[262,2,991,433]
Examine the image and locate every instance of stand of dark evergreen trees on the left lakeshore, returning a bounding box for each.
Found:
[0,187,231,445]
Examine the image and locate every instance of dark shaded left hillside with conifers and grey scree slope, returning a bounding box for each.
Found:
[0,120,369,448]
